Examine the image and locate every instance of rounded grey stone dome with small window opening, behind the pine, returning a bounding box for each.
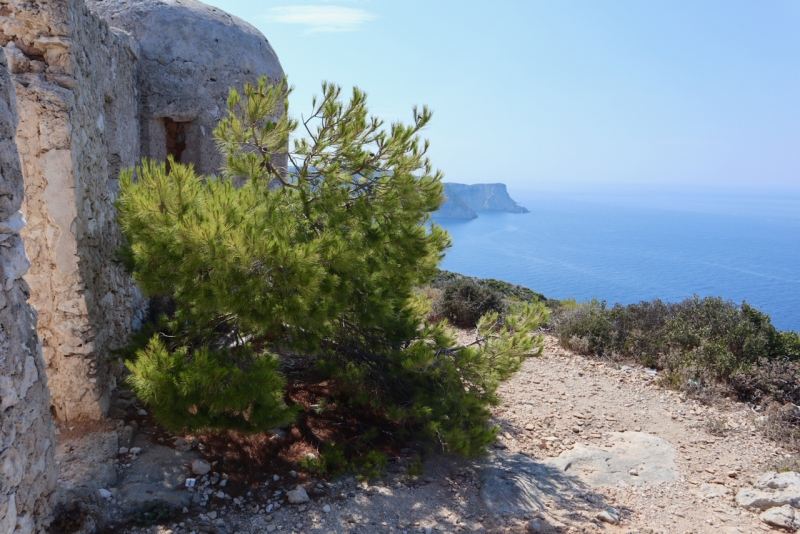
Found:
[88,0,286,174]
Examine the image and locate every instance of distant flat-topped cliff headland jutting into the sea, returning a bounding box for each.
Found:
[432,183,528,219]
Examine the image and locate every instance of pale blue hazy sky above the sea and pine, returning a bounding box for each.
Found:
[206,0,800,190]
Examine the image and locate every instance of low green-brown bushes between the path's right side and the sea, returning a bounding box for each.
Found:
[553,297,800,403]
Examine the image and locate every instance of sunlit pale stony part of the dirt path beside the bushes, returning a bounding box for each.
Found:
[484,337,788,532]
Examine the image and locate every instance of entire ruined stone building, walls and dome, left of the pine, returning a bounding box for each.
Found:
[0,0,283,532]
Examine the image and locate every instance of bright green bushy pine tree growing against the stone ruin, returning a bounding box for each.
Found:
[117,77,546,455]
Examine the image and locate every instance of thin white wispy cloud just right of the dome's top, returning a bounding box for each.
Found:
[267,6,375,33]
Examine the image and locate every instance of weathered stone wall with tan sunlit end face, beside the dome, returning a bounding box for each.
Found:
[0,0,140,428]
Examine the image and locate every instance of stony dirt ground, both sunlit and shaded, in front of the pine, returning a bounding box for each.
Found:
[114,337,788,534]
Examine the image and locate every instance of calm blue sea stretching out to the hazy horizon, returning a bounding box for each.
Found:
[436,187,800,331]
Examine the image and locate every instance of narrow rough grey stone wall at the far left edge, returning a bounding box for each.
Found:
[0,46,57,534]
